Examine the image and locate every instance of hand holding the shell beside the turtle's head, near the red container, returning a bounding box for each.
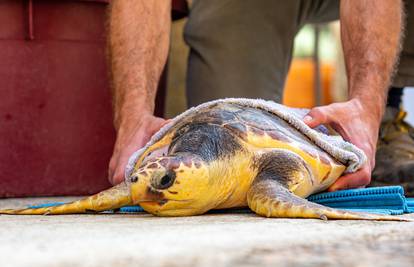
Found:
[108,113,168,185]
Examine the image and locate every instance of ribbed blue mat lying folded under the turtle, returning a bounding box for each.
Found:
[28,186,414,215]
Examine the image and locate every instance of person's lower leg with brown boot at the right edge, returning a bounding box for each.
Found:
[371,1,414,196]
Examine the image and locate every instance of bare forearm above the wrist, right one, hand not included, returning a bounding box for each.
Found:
[340,0,403,120]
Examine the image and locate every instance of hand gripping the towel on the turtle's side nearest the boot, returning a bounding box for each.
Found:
[303,99,380,191]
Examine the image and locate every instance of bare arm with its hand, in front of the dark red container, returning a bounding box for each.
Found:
[108,0,171,184]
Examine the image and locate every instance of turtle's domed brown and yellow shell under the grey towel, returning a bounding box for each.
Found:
[131,102,345,189]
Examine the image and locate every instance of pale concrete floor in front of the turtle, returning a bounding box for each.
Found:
[0,198,414,267]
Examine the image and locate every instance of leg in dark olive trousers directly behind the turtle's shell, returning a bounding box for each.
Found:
[185,0,301,106]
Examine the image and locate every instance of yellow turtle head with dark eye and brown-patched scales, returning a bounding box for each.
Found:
[129,153,211,216]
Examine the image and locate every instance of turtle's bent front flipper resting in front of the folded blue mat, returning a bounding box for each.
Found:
[247,150,407,221]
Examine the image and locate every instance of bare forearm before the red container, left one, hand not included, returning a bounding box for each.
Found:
[108,0,171,129]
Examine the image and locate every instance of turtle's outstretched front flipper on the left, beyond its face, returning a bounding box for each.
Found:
[0,182,132,215]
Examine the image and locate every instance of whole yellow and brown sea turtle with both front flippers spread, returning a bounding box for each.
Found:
[0,101,408,220]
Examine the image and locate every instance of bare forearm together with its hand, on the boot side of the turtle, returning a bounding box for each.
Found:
[304,0,403,190]
